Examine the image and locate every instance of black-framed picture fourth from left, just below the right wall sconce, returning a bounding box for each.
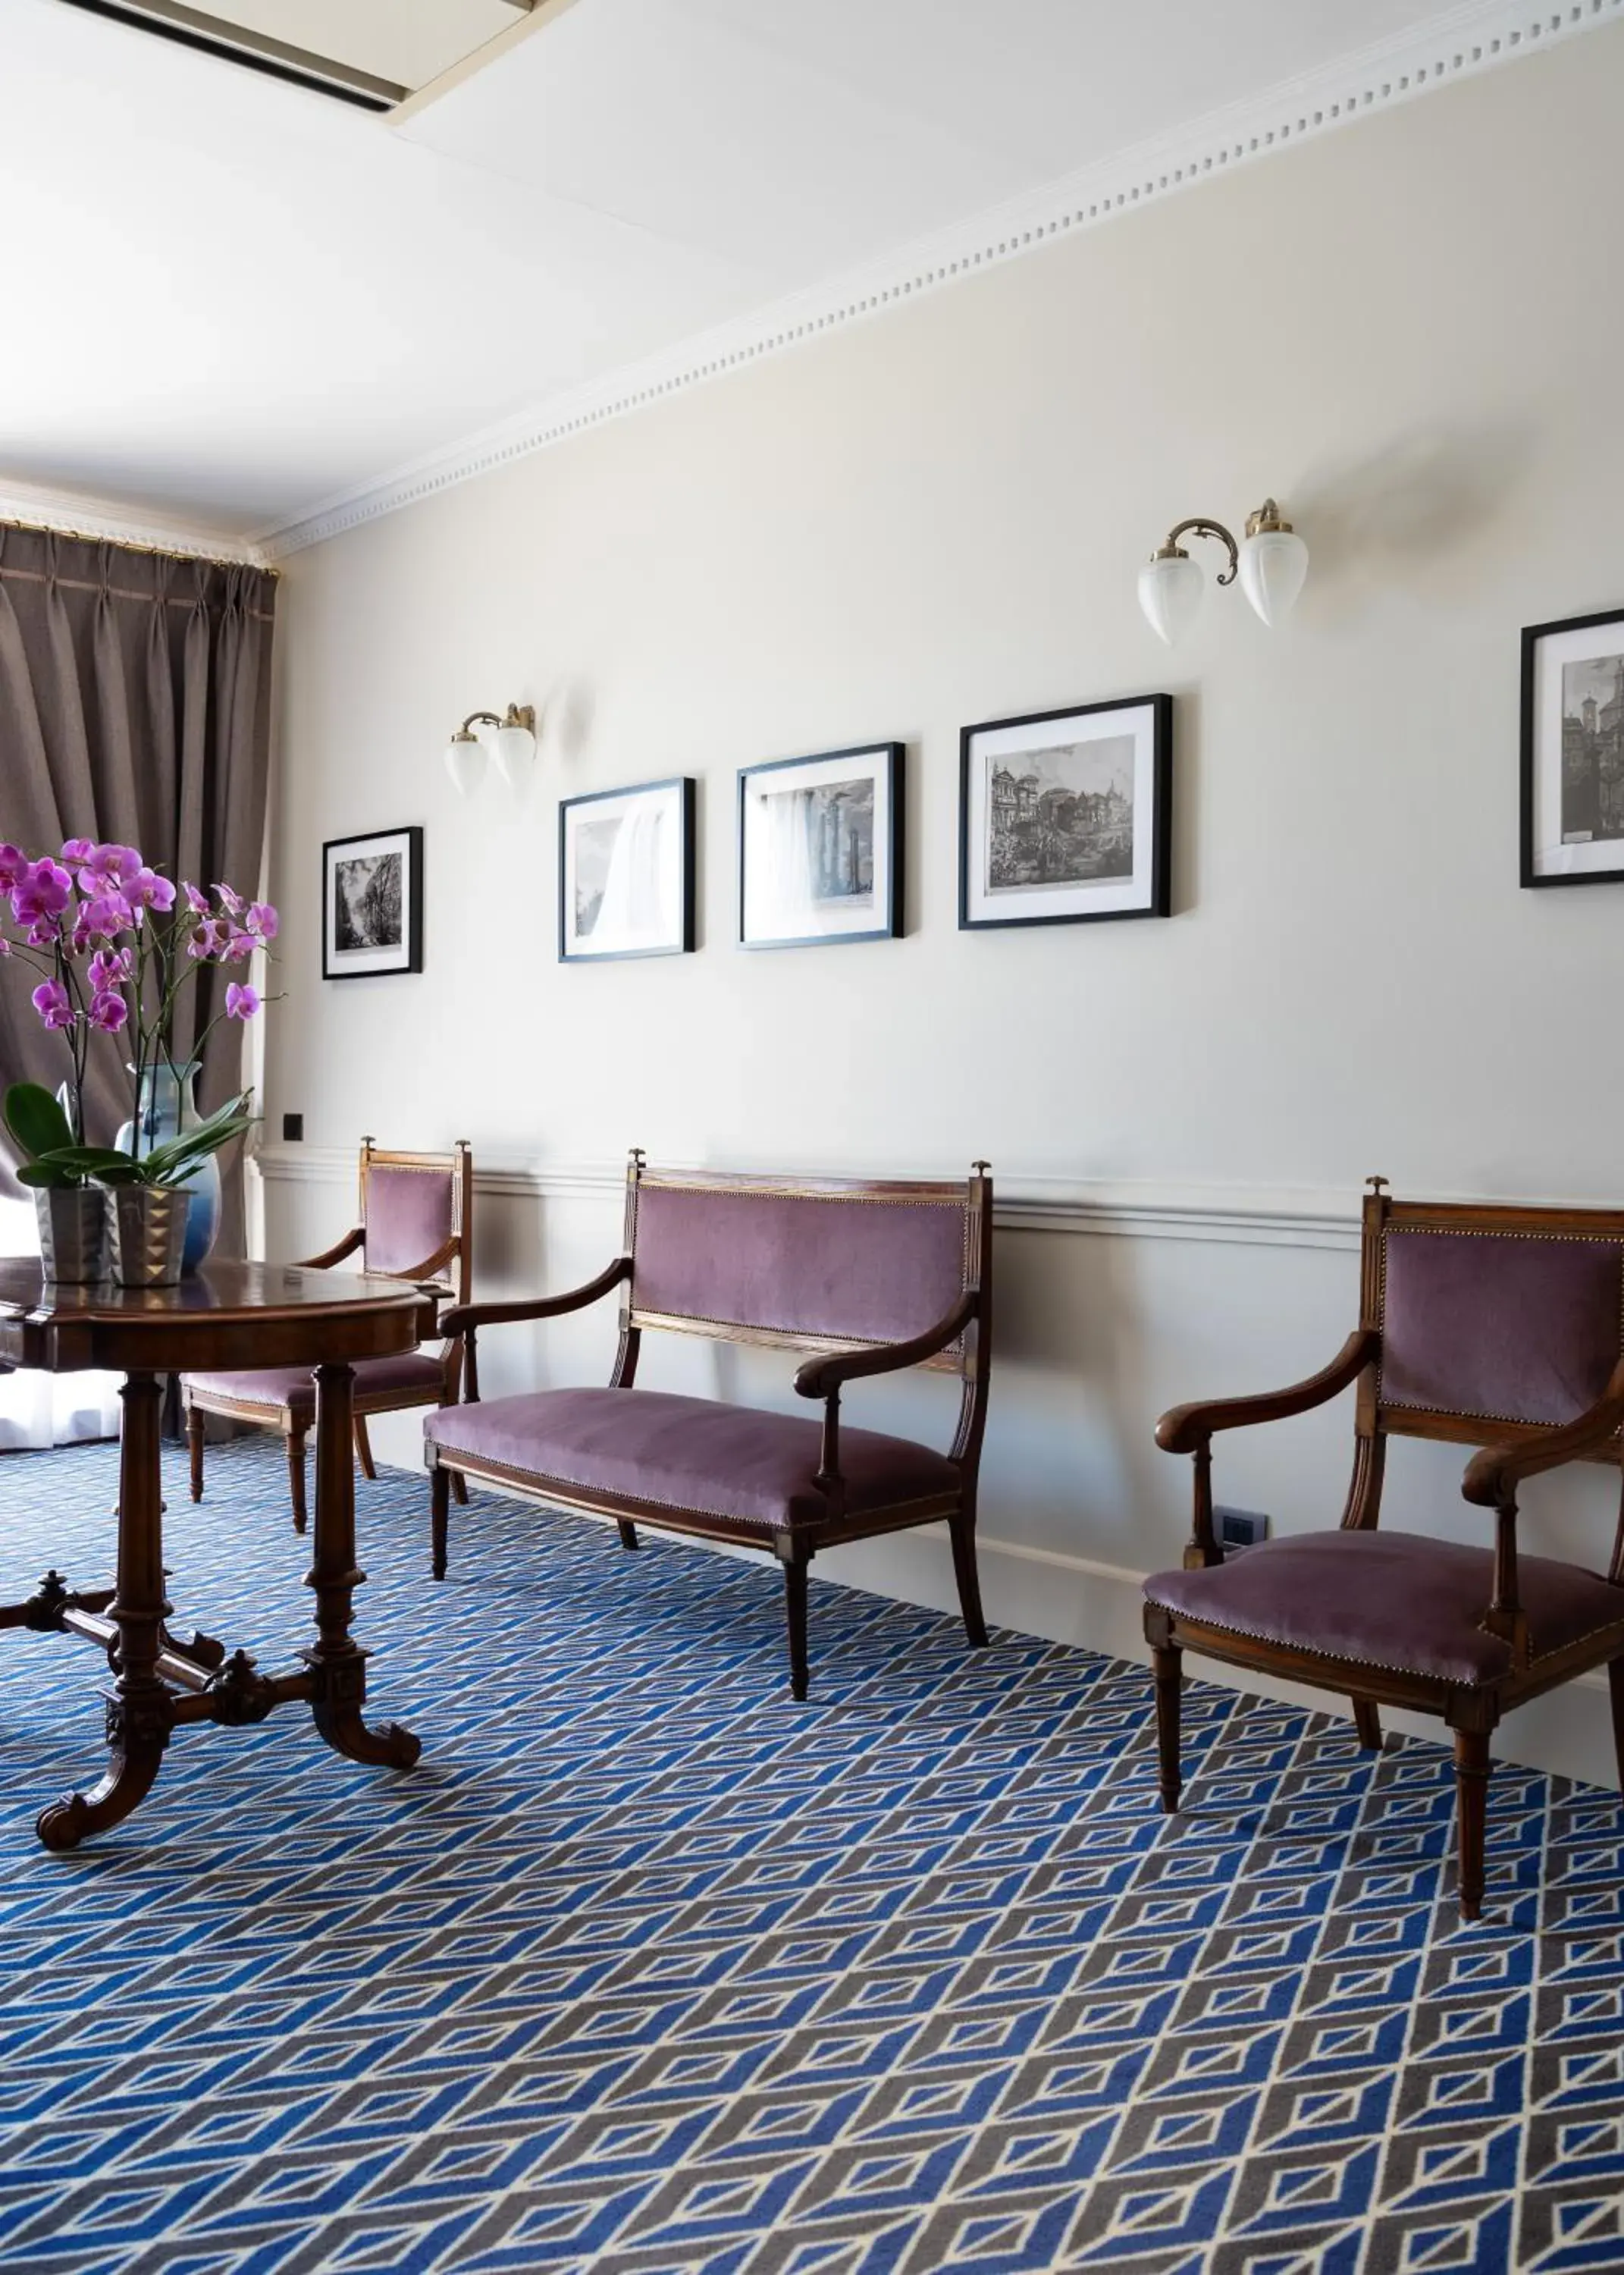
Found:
[958,696,1174,930]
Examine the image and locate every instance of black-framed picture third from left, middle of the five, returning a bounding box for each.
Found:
[739,742,903,949]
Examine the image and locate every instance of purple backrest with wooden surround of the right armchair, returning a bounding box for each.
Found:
[1367,1203,1624,1438]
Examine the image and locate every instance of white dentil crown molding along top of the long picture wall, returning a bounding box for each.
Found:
[250,0,1624,562]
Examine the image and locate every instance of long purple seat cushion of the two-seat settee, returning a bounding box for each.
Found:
[423,1390,960,1531]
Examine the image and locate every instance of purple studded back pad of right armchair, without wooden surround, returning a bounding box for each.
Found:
[1381,1231,1624,1422]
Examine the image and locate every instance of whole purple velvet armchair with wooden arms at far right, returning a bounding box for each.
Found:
[1144,1178,1624,1920]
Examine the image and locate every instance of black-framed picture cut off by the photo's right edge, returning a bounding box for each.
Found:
[1522,610,1624,885]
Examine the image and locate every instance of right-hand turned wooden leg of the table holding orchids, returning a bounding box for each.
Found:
[305,1367,423,1770]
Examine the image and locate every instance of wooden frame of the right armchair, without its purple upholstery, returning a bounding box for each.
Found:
[1144,1178,1624,1920]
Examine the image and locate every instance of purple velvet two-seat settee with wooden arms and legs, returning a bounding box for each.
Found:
[423,1153,992,1699]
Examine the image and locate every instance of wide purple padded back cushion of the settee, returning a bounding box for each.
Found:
[632,1176,967,1342]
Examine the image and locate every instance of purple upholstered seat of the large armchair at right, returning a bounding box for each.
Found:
[1144,1531,1624,1684]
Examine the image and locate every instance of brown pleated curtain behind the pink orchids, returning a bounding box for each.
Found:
[0,523,275,1256]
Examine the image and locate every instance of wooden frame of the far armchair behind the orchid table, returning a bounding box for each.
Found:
[182,1138,473,1533]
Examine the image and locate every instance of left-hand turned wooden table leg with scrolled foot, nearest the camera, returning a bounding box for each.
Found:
[36,1374,171,1850]
